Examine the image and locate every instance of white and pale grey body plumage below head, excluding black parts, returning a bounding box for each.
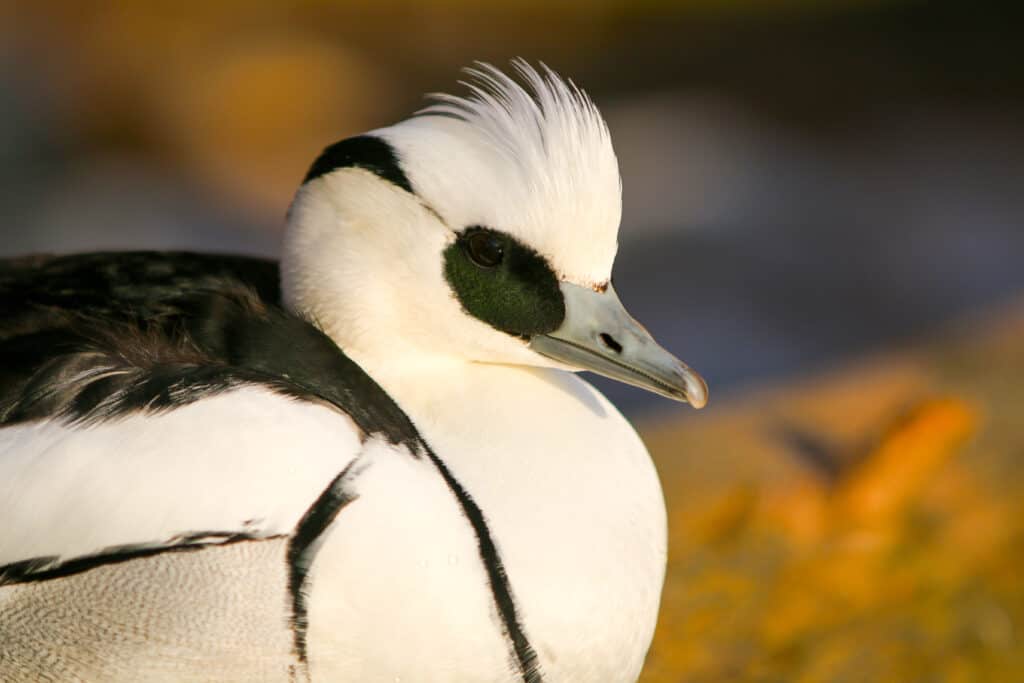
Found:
[0,376,666,683]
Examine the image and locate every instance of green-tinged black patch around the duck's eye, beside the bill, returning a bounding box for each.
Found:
[444,226,565,338]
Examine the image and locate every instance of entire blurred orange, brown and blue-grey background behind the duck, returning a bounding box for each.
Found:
[0,0,1024,682]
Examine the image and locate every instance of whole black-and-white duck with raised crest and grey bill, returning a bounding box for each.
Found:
[0,59,708,683]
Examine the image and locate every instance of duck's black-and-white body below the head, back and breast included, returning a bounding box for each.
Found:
[0,253,665,681]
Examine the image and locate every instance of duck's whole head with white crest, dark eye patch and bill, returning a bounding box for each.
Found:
[283,60,707,405]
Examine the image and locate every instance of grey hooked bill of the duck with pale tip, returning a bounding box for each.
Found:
[529,283,708,409]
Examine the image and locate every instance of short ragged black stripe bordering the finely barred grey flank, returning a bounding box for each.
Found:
[288,460,359,666]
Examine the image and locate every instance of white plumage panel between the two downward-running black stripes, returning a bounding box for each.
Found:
[301,442,512,683]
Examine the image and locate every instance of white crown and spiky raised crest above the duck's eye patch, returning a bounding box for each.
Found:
[388,59,622,284]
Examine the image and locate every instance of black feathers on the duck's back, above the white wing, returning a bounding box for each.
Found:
[0,252,419,444]
